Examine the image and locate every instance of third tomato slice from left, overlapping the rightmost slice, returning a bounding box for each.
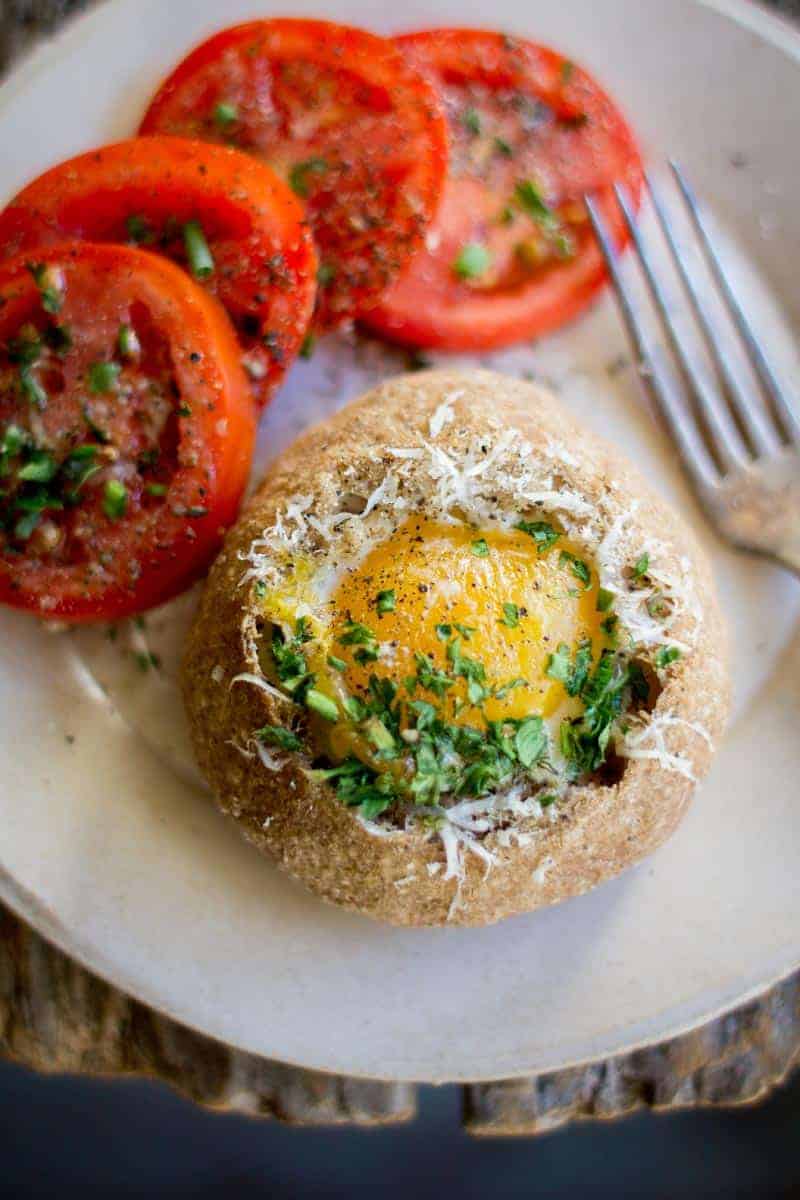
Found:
[142,20,446,331]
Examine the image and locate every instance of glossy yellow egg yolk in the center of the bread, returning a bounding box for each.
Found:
[331,517,606,724]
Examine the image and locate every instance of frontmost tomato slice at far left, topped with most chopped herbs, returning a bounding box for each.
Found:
[0,242,255,622]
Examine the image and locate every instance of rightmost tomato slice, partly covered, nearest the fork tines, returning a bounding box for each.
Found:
[366,29,642,350]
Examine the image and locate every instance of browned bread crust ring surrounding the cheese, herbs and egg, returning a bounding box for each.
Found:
[182,371,729,925]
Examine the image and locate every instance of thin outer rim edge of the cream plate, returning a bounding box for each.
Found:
[0,0,800,1084]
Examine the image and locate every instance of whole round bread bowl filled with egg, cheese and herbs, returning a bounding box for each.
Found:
[182,371,728,925]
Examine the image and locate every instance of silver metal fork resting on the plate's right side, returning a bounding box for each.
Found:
[585,162,800,575]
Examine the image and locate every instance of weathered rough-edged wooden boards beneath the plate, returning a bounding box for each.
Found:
[0,0,800,1136]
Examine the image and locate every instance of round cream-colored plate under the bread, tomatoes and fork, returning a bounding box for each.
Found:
[0,0,800,1081]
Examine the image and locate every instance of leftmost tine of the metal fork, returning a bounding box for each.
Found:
[585,196,718,488]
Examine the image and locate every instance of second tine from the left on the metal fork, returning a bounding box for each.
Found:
[614,184,747,470]
